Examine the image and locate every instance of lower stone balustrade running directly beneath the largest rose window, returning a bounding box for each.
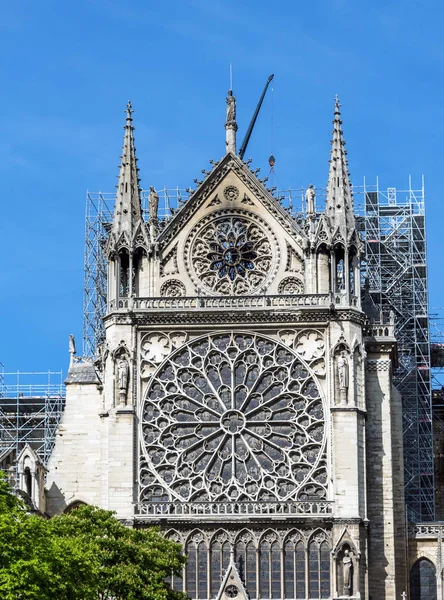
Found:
[136,501,333,520]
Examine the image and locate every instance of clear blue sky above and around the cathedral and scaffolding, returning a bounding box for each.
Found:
[0,0,444,371]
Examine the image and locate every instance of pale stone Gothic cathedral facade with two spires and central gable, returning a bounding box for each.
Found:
[42,93,407,600]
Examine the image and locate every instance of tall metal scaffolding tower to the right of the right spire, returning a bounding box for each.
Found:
[363,177,434,521]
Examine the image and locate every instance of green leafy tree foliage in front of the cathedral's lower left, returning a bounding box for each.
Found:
[0,478,185,600]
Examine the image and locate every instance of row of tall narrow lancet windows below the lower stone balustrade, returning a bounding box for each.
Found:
[173,531,331,600]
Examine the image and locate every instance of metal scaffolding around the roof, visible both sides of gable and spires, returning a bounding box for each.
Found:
[83,181,434,521]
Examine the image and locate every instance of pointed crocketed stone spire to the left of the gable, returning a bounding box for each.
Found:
[112,102,142,243]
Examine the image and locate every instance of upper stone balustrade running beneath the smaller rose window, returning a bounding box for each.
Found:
[109,294,340,311]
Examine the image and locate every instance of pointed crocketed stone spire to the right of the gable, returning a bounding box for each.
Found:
[325,96,355,236]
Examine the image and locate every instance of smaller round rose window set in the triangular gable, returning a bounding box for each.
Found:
[186,211,277,295]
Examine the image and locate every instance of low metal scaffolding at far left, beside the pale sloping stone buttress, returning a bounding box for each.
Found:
[0,366,65,468]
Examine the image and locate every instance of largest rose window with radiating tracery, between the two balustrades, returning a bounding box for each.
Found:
[140,333,327,502]
